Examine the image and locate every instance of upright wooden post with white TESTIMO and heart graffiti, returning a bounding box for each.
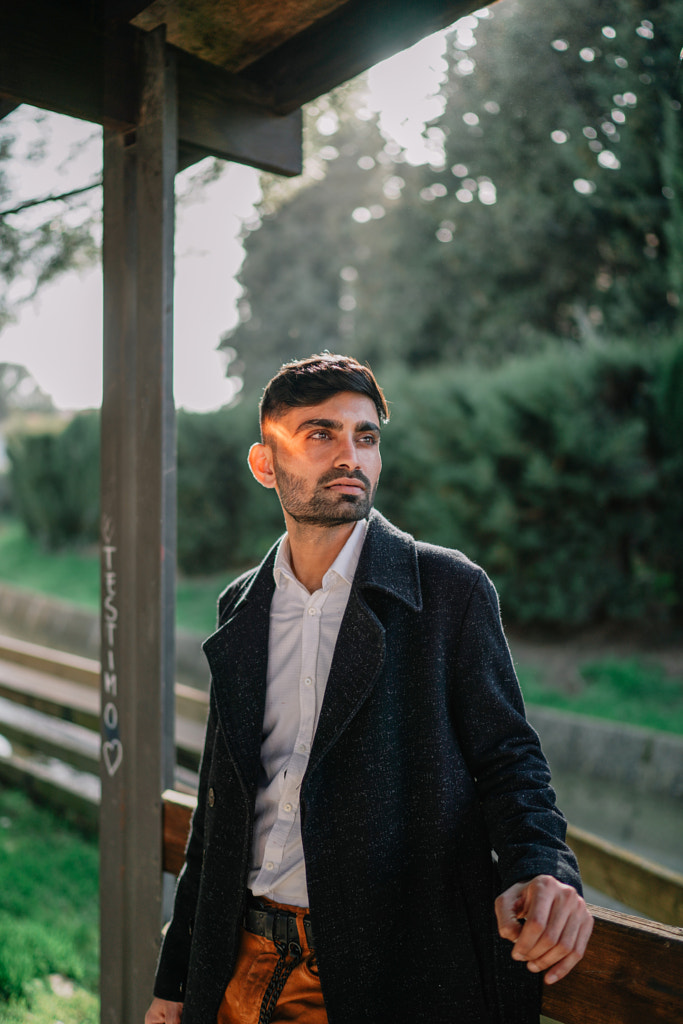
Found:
[100,27,177,1024]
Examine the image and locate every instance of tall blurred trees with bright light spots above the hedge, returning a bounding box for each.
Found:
[225,0,683,383]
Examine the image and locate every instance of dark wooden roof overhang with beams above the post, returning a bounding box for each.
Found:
[0,0,480,174]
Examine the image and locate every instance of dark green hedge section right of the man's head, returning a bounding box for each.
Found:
[378,342,683,625]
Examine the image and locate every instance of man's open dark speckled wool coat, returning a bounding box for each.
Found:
[155,512,581,1024]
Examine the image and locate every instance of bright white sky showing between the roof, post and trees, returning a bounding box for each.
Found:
[0,22,471,412]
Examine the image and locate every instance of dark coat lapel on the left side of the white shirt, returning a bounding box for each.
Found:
[203,548,275,790]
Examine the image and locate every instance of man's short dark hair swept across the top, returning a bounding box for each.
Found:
[259,352,389,433]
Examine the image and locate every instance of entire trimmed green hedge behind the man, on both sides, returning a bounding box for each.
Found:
[5,340,683,626]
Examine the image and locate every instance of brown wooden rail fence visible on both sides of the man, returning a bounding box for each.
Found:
[0,638,683,1024]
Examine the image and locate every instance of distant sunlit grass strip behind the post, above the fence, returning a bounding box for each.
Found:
[0,518,225,636]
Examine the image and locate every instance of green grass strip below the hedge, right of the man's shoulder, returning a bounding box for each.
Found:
[519,657,683,735]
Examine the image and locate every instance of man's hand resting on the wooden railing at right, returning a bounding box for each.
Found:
[496,874,593,985]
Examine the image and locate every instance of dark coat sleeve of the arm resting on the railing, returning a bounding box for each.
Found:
[454,571,581,892]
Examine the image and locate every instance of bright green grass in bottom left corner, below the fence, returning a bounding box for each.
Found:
[0,791,99,1024]
